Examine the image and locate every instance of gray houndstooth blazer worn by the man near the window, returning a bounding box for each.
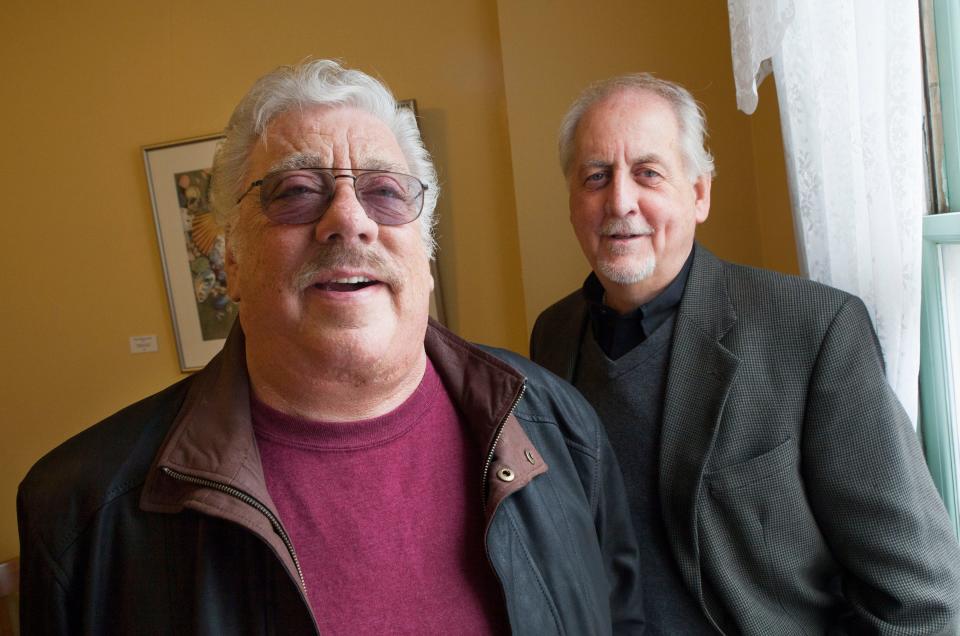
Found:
[530,246,960,635]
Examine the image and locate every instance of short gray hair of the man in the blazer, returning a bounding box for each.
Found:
[557,73,714,181]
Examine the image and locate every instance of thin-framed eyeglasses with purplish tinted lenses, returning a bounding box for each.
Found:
[237,168,427,225]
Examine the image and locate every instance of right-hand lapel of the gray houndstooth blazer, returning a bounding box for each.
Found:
[660,245,740,603]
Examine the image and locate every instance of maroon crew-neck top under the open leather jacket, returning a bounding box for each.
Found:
[252,360,507,634]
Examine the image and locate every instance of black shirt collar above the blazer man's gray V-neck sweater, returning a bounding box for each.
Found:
[583,249,694,360]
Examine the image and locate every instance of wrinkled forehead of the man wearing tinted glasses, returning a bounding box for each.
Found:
[248,106,408,178]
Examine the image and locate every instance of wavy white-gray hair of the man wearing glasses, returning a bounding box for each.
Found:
[210,60,440,258]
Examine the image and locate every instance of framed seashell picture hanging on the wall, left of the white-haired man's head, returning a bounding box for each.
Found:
[143,135,237,371]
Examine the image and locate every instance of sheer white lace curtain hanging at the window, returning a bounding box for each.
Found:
[727,0,926,422]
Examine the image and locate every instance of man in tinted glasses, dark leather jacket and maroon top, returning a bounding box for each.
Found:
[18,61,642,634]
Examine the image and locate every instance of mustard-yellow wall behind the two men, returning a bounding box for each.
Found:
[0,0,795,559]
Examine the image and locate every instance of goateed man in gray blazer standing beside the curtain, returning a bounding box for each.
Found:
[530,74,960,635]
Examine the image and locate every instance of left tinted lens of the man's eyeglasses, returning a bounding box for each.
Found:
[260,170,334,224]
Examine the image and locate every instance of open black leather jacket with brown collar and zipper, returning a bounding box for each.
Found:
[17,325,642,636]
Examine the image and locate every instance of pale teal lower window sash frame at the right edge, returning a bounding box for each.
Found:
[920,212,960,537]
